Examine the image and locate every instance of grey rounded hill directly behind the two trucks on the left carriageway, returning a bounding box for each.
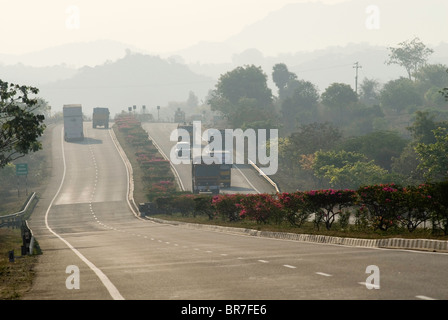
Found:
[40,52,215,115]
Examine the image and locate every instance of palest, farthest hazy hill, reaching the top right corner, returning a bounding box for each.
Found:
[225,0,448,56]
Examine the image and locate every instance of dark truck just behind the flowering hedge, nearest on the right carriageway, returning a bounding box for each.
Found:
[191,157,221,194]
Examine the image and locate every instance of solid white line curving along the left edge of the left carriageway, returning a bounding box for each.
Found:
[45,127,124,300]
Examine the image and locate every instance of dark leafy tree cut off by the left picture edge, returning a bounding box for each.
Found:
[0,80,45,168]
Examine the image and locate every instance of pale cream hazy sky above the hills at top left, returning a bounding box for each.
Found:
[0,0,347,54]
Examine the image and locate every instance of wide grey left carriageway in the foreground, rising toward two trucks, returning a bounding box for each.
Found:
[24,123,448,302]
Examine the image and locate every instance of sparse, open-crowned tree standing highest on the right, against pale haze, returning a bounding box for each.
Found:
[386,37,434,80]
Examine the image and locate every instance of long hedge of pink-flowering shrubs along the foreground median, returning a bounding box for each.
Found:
[157,182,448,235]
